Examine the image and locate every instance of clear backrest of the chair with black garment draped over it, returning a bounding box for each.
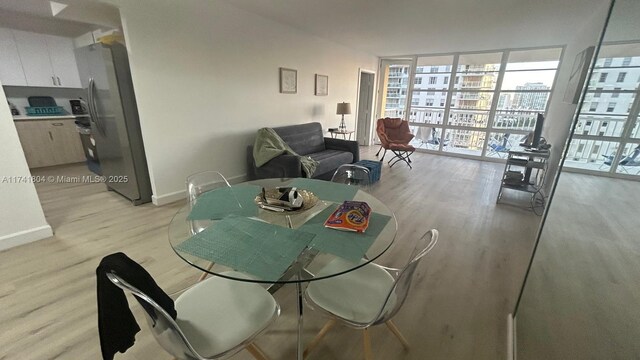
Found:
[107,273,205,360]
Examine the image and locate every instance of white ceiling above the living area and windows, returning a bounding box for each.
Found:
[229,0,609,56]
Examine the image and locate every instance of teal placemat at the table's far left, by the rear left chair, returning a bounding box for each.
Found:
[187,185,261,220]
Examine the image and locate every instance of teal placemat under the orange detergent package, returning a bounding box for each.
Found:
[299,205,391,262]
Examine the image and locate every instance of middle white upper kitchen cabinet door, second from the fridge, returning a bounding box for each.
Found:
[13,30,57,87]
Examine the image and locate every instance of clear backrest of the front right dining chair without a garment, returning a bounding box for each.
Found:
[370,229,438,325]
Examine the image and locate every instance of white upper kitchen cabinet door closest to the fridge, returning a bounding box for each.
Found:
[45,35,82,88]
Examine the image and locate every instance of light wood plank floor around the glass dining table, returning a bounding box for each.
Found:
[0,148,540,360]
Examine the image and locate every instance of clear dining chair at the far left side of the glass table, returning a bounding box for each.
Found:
[187,170,240,281]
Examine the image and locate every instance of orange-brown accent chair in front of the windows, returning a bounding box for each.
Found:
[376,118,416,168]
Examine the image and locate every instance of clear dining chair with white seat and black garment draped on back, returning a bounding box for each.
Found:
[107,272,280,360]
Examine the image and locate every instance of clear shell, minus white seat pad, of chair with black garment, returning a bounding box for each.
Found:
[107,272,280,360]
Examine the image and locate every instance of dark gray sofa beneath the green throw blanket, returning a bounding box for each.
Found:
[247,123,360,180]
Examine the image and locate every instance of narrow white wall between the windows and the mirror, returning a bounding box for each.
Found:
[543,3,609,193]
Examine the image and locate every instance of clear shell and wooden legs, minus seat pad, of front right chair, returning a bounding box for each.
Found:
[304,229,439,360]
